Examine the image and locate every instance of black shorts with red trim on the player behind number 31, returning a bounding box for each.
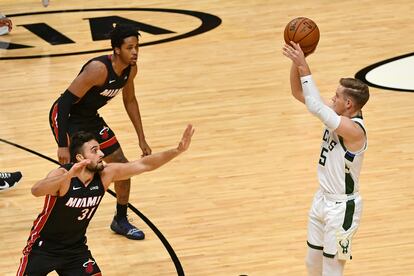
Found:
[49,102,120,156]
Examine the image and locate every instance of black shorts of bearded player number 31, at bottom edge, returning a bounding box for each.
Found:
[17,242,101,276]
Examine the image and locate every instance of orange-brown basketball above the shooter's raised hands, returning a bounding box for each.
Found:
[284,17,319,55]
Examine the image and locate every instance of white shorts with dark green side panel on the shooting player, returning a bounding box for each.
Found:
[308,190,362,258]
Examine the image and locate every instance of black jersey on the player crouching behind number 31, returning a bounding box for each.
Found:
[70,55,131,119]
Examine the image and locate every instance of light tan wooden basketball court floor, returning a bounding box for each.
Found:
[0,0,414,276]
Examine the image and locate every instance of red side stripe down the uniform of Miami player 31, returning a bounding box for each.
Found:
[17,195,57,276]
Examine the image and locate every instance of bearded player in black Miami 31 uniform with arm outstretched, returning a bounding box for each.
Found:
[17,125,194,276]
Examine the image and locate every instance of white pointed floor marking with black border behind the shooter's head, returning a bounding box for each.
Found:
[355,53,414,92]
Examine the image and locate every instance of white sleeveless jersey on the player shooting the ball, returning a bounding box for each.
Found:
[318,117,368,194]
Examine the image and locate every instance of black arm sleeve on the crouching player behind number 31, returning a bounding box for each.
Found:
[57,90,79,147]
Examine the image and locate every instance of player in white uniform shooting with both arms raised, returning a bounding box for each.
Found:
[283,42,369,276]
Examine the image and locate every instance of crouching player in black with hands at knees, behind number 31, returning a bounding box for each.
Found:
[49,25,151,240]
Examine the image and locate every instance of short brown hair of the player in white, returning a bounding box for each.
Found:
[339,78,369,109]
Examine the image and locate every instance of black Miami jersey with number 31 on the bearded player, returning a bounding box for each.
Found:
[23,164,105,253]
